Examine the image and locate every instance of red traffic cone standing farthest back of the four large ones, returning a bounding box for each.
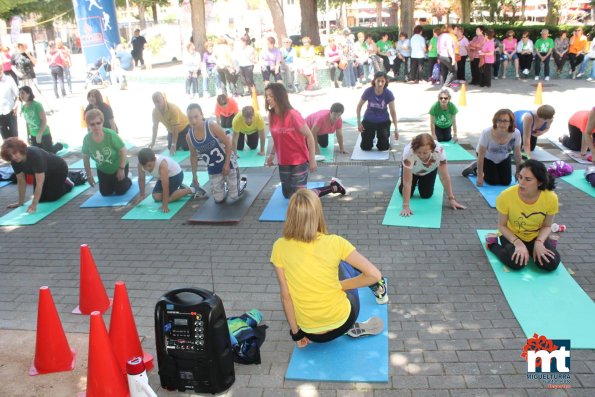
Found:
[72,244,112,314]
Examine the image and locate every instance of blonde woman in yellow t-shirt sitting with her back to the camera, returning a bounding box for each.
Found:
[271,189,388,347]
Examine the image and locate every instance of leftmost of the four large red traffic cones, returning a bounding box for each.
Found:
[29,287,76,376]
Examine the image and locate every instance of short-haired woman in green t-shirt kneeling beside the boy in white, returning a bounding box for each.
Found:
[81,109,132,196]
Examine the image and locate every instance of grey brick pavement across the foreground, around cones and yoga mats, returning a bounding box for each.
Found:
[0,72,595,397]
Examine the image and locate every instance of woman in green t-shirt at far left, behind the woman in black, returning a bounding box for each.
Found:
[19,85,63,153]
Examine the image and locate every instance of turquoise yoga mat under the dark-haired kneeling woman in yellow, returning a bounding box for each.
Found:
[477,230,595,349]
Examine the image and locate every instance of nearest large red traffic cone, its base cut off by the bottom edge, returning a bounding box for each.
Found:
[86,311,130,397]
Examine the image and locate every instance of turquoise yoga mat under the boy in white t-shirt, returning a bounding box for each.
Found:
[122,172,209,221]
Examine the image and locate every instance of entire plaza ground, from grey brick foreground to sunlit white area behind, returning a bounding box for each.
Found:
[0,59,595,397]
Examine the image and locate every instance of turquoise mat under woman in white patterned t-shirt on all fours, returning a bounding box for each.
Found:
[382,177,444,229]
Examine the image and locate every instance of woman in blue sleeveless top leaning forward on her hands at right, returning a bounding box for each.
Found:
[514,105,556,158]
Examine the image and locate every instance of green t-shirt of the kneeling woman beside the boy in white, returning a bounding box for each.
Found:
[81,128,128,174]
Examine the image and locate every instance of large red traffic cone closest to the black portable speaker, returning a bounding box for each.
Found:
[109,281,153,374]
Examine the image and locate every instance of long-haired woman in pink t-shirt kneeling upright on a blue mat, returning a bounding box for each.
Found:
[264,83,346,198]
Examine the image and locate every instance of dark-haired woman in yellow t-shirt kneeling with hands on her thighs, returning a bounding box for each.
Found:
[486,160,560,271]
